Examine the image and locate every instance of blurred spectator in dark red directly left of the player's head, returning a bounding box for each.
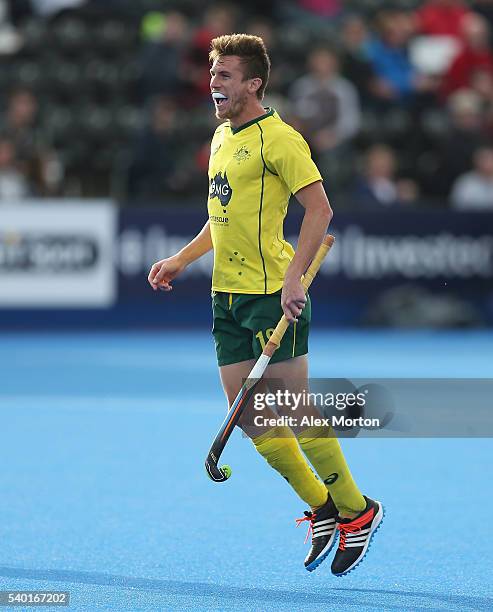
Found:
[183,4,235,107]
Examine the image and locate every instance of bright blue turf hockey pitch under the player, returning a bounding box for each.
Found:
[0,331,493,612]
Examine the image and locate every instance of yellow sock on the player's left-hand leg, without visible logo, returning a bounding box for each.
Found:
[252,427,327,508]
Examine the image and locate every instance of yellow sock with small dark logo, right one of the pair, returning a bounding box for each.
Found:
[298,427,366,515]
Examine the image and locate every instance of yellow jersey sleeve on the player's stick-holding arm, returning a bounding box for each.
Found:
[264,129,322,193]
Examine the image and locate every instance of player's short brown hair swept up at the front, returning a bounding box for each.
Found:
[209,34,270,100]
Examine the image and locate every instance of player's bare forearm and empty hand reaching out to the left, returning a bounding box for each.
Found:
[147,221,212,291]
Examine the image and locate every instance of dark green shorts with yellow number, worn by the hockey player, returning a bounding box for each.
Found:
[212,291,311,366]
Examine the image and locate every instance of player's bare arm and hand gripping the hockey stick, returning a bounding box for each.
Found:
[281,181,332,323]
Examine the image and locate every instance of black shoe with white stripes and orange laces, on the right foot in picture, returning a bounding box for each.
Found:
[331,496,384,576]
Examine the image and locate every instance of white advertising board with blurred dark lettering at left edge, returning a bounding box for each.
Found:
[0,200,117,308]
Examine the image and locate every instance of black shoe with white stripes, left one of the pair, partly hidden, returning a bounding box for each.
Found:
[296,496,337,572]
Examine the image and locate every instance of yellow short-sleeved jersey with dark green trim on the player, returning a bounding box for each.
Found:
[208,109,322,294]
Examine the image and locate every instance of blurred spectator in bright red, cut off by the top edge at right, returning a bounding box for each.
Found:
[416,0,469,38]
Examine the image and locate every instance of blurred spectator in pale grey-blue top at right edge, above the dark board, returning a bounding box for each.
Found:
[450,147,493,210]
